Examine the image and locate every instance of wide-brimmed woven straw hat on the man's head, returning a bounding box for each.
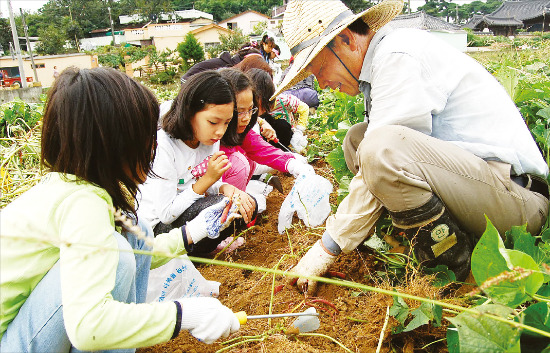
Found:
[271,0,403,99]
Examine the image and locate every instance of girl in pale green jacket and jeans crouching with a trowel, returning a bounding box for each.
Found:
[0,68,239,352]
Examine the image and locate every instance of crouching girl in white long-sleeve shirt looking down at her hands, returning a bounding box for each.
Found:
[138,70,256,255]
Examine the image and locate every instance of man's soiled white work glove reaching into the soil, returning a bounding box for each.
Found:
[290,240,337,295]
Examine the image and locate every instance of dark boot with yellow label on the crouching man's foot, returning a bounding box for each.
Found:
[390,195,474,282]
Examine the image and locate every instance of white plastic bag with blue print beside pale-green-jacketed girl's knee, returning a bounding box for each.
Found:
[150,255,220,303]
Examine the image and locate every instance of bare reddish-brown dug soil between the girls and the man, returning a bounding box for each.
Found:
[139,171,458,353]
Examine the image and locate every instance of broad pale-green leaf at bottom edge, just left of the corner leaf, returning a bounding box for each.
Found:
[449,304,521,353]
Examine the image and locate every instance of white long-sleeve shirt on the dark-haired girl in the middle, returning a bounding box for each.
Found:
[137,129,224,227]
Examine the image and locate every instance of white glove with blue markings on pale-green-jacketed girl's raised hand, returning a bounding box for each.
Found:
[185,197,241,244]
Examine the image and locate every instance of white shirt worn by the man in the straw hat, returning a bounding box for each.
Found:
[359,25,548,176]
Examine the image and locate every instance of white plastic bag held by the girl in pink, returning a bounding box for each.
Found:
[278,174,332,233]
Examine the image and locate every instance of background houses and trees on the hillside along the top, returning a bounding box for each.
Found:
[0,0,550,87]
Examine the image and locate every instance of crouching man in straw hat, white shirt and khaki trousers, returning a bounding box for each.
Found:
[280,0,548,292]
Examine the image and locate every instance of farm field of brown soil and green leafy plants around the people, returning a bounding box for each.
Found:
[0,41,550,353]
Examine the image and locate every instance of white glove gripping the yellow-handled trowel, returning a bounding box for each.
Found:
[178,297,241,344]
